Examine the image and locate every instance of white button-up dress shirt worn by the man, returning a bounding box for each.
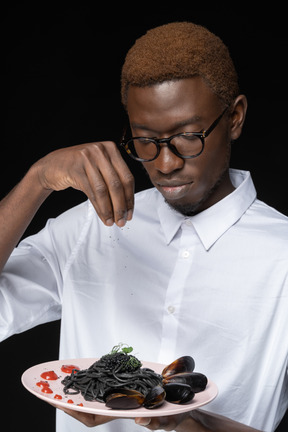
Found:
[0,170,288,432]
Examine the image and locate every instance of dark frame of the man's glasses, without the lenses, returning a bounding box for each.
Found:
[120,107,228,162]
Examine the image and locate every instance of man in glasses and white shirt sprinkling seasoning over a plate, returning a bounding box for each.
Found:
[0,23,288,432]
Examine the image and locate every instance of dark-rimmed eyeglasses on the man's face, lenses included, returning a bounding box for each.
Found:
[120,107,228,162]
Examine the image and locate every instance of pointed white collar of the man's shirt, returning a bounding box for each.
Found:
[158,169,256,250]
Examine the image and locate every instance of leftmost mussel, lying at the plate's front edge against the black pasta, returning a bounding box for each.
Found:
[104,388,145,409]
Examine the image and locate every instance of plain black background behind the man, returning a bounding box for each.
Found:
[0,2,288,432]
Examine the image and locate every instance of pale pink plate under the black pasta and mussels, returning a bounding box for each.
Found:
[22,358,218,418]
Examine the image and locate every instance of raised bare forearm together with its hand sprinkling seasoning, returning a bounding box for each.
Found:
[0,141,134,271]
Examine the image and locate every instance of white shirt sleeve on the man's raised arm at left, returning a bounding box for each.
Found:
[0,203,91,341]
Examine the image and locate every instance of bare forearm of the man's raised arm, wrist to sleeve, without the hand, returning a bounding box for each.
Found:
[0,167,52,271]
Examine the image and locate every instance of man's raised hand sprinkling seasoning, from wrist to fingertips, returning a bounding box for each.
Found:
[33,141,134,227]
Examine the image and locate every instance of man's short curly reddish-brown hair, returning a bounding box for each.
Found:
[121,21,239,107]
